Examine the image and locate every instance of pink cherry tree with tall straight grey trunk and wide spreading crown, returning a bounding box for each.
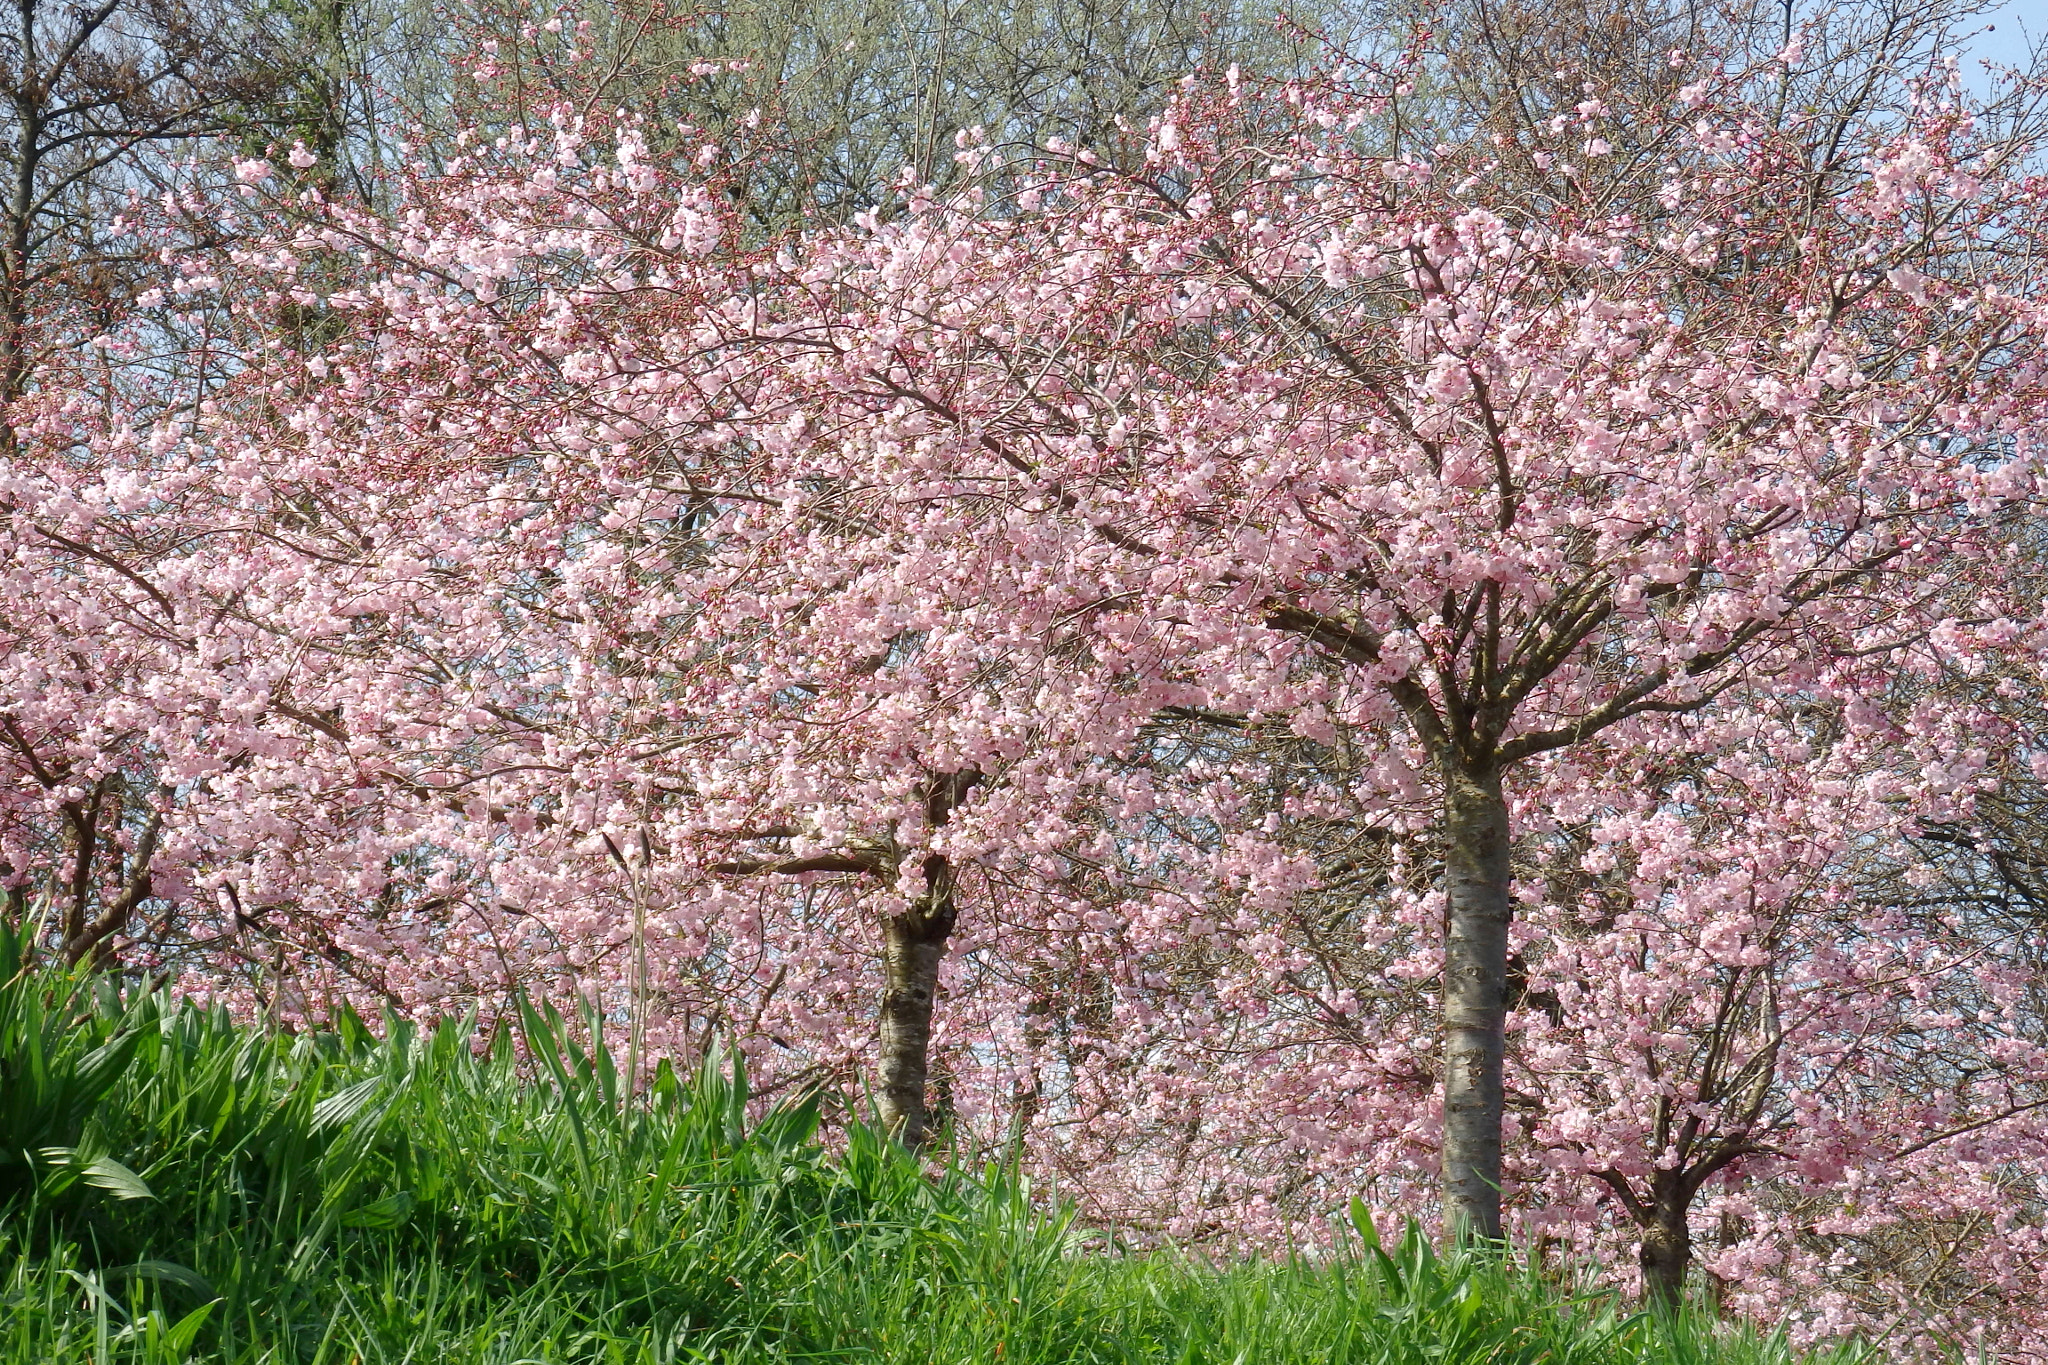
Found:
[663,40,2038,1260]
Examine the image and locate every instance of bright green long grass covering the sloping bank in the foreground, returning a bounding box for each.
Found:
[0,925,1851,1365]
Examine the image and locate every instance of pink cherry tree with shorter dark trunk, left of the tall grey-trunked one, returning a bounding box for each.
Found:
[12,113,1155,1144]
